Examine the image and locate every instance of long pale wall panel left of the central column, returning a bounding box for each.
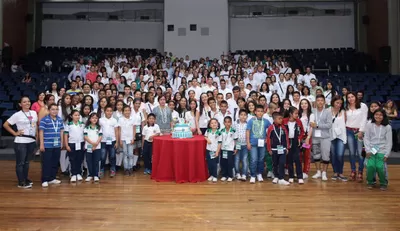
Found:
[42,20,163,51]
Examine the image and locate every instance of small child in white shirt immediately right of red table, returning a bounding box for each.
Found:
[204,118,221,182]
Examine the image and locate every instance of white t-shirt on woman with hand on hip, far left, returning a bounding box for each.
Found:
[7,110,38,144]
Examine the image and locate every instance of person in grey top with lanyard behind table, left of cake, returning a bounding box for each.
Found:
[153,95,172,134]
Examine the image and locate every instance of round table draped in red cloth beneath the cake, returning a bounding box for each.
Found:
[151,135,208,183]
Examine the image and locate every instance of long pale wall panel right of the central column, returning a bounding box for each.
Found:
[230,16,354,51]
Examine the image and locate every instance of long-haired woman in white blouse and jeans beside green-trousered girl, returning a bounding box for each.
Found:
[345,92,368,182]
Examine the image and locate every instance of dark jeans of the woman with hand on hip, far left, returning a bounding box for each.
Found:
[14,142,36,183]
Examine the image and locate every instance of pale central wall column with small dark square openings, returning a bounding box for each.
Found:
[164,0,229,58]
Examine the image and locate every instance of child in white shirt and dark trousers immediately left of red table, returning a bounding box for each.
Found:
[142,113,161,175]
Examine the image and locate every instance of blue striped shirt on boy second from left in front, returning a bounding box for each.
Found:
[39,115,64,148]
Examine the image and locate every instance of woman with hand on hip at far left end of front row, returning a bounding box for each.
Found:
[3,96,38,188]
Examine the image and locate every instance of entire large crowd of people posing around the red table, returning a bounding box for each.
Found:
[4,53,397,190]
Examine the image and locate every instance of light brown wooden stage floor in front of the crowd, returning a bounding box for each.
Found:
[0,161,400,231]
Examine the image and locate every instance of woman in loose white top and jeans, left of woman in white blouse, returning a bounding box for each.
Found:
[329,95,347,181]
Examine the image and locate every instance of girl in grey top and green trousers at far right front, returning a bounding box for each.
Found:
[364,109,392,191]
